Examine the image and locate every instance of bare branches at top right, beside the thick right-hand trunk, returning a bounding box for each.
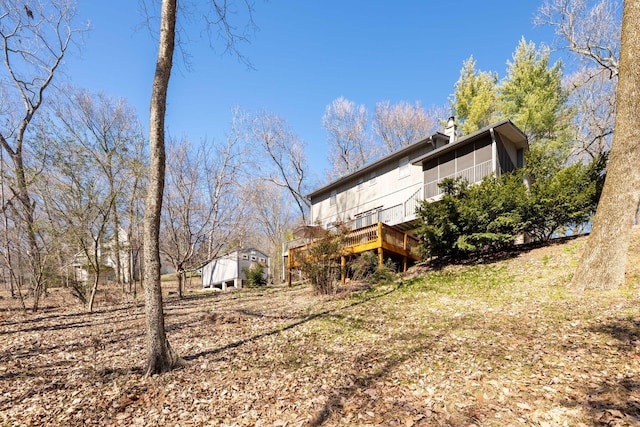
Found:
[534,0,620,77]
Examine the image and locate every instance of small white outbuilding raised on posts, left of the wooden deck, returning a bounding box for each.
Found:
[202,248,270,291]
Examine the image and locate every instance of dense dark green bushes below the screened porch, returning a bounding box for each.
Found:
[418,152,607,258]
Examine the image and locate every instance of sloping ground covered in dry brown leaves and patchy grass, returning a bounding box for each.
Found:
[0,233,640,426]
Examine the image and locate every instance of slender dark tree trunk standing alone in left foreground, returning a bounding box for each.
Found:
[144,0,184,375]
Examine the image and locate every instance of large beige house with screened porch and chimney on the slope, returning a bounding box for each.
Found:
[308,118,529,231]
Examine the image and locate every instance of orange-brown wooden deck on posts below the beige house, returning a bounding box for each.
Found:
[287,222,420,285]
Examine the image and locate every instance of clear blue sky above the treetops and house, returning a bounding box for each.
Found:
[66,0,557,181]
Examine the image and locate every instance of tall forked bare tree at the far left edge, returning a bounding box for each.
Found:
[0,0,81,311]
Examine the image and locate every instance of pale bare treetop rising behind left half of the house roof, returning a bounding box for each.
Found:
[322,97,372,178]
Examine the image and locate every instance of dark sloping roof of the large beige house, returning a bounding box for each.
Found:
[307,119,529,198]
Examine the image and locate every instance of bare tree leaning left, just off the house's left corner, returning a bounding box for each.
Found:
[251,113,310,223]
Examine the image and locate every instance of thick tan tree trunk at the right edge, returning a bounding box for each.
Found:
[571,1,640,291]
